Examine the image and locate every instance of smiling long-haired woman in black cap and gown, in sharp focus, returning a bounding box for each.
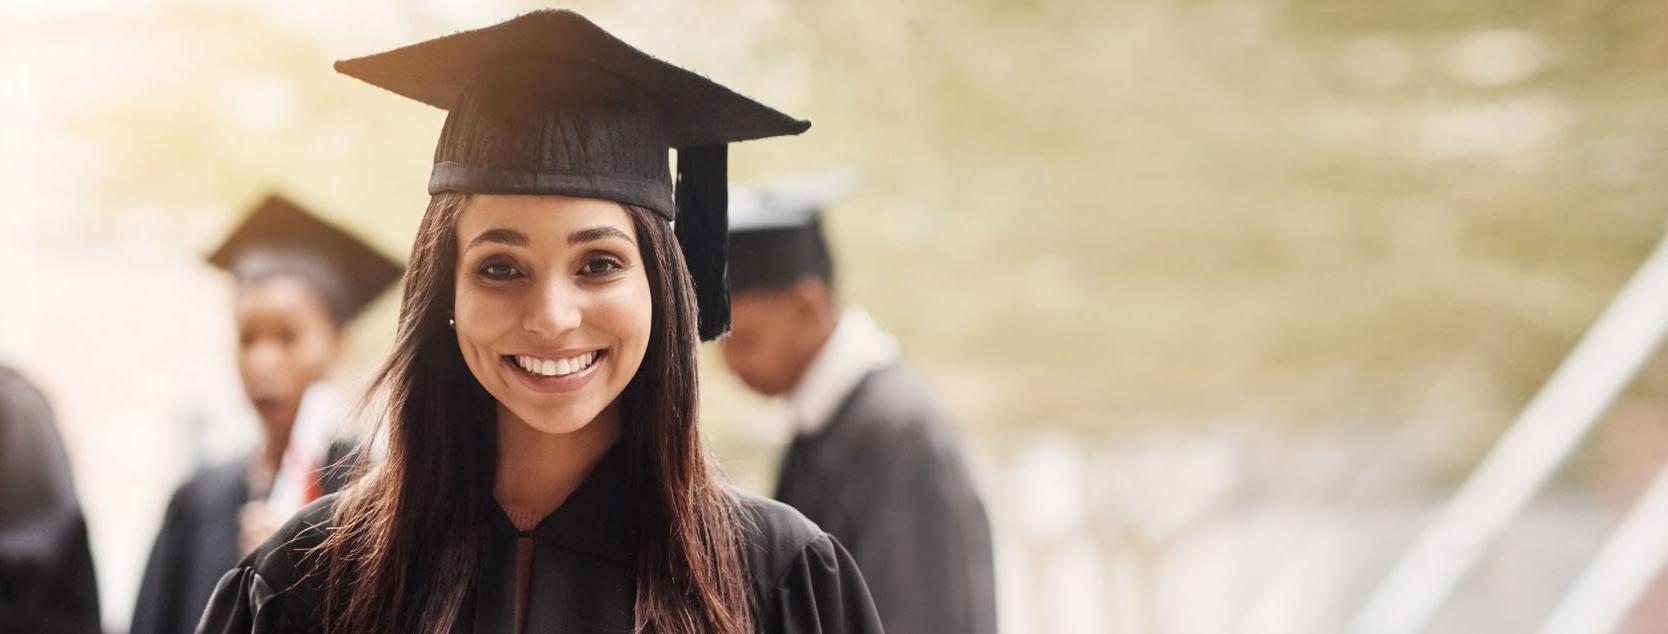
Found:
[200,10,881,634]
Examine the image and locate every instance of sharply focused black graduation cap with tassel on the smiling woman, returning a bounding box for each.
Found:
[335,10,811,340]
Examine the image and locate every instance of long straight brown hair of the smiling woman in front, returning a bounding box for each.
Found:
[320,194,752,634]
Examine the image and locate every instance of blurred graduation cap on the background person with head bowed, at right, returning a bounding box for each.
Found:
[729,170,857,292]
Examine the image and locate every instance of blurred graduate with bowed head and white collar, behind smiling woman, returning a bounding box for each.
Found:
[721,172,996,634]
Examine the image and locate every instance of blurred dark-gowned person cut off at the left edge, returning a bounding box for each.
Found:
[0,365,100,634]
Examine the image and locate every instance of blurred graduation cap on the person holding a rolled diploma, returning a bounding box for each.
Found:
[209,194,405,324]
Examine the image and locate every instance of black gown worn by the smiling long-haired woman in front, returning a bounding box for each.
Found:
[198,449,881,634]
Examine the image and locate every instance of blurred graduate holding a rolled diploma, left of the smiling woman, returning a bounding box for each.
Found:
[130,195,402,634]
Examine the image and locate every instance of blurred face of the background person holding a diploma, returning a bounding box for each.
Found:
[237,275,342,429]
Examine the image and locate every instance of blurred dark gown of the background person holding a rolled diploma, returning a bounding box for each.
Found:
[128,442,358,634]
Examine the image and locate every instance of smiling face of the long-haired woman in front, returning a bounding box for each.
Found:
[454,195,654,434]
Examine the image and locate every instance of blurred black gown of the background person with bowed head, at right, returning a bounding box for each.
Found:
[776,364,996,634]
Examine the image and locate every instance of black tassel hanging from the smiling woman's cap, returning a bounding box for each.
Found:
[674,143,729,342]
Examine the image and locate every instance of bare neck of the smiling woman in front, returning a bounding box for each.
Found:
[492,405,620,517]
